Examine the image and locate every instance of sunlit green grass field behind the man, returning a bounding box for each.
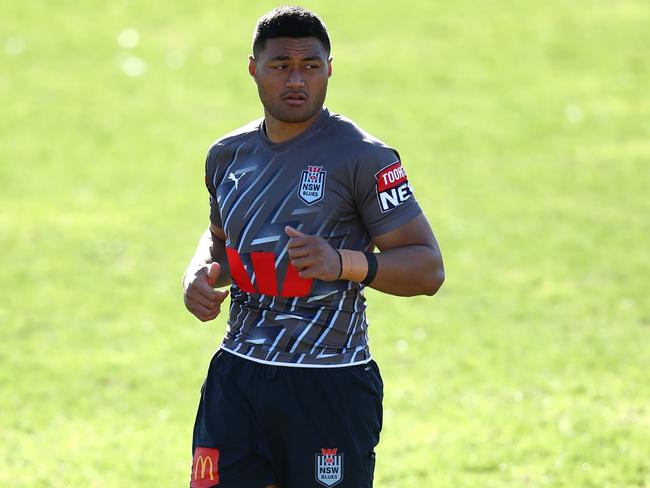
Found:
[0,0,650,488]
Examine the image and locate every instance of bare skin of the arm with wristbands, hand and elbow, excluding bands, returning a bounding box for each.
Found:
[286,214,445,296]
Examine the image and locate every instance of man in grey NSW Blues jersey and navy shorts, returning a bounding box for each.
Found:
[183,7,444,488]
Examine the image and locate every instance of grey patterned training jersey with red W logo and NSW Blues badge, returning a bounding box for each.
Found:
[205,109,421,367]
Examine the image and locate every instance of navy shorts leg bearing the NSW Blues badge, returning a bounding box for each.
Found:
[260,361,383,488]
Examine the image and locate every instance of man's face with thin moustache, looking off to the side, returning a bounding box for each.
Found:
[248,37,332,123]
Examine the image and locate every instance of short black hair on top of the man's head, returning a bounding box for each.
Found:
[253,7,332,56]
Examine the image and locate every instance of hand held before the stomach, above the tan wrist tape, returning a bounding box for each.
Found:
[284,226,341,281]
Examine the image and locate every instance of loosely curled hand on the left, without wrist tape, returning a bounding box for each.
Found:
[184,263,228,322]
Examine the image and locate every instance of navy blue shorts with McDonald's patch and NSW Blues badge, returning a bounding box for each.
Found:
[190,350,383,488]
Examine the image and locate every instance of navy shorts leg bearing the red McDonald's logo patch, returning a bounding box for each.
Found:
[190,350,275,488]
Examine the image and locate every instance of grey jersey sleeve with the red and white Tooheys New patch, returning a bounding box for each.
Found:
[354,146,422,237]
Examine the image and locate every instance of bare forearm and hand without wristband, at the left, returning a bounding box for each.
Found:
[183,225,231,322]
